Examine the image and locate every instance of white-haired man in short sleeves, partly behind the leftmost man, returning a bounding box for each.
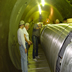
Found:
[23,23,32,63]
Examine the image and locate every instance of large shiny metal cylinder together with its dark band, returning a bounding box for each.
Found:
[40,24,72,72]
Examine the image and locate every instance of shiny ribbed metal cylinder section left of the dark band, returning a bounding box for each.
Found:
[40,24,72,72]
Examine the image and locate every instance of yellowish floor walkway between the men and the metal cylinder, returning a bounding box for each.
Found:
[28,45,51,72]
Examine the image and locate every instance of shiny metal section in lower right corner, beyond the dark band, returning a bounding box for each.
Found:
[60,43,72,72]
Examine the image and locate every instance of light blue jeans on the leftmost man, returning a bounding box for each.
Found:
[19,45,28,72]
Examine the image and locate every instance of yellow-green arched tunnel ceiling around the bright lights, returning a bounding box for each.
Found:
[22,0,72,22]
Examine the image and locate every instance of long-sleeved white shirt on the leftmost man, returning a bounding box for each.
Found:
[17,28,26,49]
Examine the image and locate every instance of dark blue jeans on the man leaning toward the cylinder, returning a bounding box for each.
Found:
[32,35,38,59]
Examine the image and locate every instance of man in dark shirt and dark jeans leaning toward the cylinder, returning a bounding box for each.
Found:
[32,23,42,61]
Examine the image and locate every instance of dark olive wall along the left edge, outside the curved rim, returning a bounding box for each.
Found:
[0,0,21,72]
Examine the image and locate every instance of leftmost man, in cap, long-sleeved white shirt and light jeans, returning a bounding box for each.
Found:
[17,20,28,72]
